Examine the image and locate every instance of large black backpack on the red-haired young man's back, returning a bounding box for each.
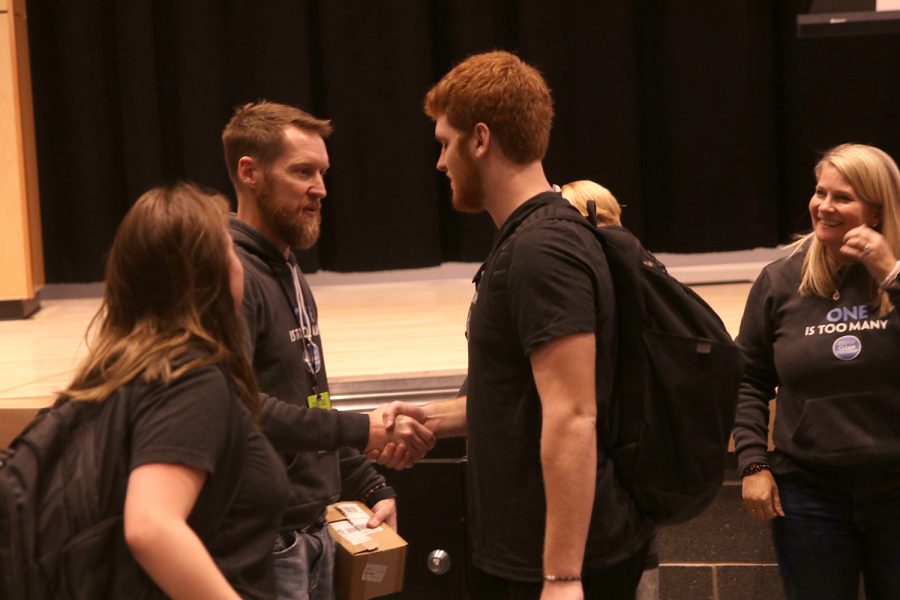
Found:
[495,203,743,524]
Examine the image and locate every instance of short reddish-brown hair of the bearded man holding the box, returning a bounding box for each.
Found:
[222,100,332,183]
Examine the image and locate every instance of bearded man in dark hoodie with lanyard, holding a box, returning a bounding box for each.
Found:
[222,101,434,600]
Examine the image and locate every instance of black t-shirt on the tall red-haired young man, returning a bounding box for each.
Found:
[466,193,652,581]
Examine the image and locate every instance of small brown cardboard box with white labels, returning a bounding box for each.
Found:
[326,502,407,600]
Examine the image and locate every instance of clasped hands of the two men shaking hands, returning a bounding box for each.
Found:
[365,401,437,469]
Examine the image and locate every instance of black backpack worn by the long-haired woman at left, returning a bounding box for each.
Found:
[0,398,165,600]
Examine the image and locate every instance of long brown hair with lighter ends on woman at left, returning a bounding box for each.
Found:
[64,183,259,418]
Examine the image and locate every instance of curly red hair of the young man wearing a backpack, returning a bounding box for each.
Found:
[425,51,553,164]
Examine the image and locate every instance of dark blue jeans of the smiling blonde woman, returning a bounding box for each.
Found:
[772,480,900,600]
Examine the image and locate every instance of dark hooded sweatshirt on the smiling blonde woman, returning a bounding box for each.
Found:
[734,250,900,490]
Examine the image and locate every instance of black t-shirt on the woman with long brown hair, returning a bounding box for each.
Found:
[127,366,287,598]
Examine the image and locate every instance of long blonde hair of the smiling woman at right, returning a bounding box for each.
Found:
[792,144,900,316]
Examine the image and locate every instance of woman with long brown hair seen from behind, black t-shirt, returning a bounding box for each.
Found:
[64,184,287,599]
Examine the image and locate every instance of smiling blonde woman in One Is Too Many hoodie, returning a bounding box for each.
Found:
[734,144,900,600]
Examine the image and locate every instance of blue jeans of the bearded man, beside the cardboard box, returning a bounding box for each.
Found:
[274,519,334,600]
